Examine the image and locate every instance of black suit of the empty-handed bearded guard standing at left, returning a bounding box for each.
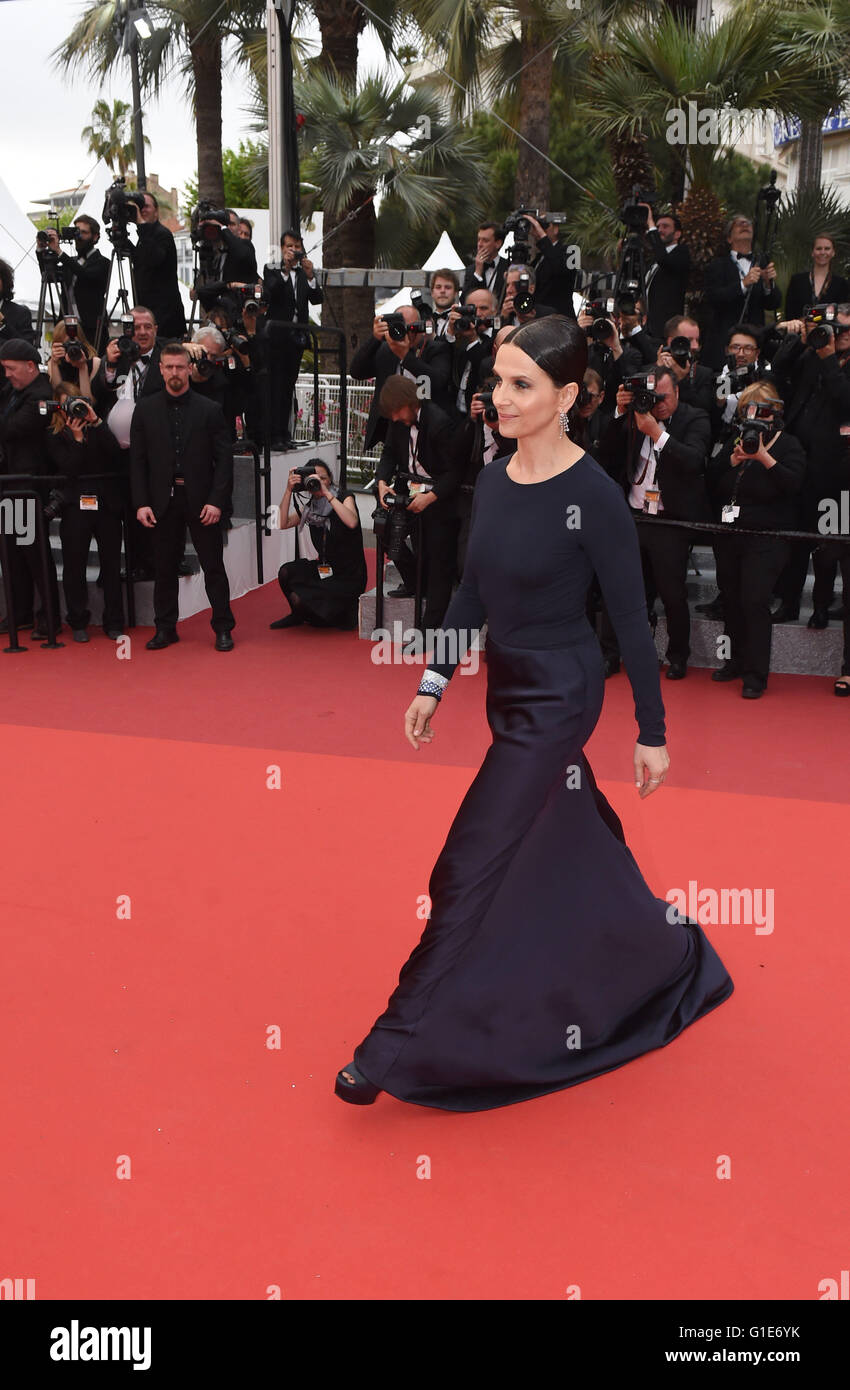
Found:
[131,389,236,632]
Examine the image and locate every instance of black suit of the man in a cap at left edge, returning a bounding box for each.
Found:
[0,373,60,627]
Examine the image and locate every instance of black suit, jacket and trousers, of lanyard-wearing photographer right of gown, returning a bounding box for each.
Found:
[601,404,711,663]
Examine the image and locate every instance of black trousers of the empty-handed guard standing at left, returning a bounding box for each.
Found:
[153,485,236,632]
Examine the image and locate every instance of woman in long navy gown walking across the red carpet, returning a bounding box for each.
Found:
[335,314,732,1111]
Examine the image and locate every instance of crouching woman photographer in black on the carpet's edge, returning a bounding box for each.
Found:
[269,459,368,631]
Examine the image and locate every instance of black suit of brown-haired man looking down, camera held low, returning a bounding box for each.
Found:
[375,400,460,630]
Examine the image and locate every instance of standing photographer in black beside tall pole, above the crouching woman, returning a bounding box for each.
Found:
[263,231,325,449]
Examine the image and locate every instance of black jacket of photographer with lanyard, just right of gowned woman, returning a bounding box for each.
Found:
[599,402,711,521]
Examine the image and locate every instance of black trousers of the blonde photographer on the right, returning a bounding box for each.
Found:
[714,534,792,688]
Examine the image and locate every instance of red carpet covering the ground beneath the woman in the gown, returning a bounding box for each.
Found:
[0,585,850,1301]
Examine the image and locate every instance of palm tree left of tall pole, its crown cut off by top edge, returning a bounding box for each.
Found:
[53,0,265,204]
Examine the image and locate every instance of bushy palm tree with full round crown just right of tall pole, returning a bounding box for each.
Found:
[296,68,486,345]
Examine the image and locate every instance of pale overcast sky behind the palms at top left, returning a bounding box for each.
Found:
[0,0,388,213]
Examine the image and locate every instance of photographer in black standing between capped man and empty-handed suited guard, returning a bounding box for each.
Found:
[46,382,126,642]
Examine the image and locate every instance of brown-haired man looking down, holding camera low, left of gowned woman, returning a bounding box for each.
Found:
[375,377,460,631]
